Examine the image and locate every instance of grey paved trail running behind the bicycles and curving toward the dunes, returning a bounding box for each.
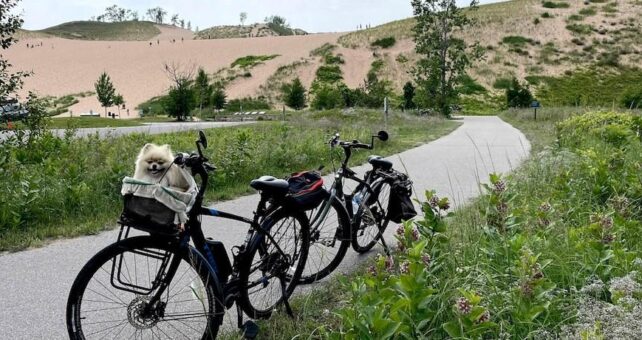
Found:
[0,117,530,339]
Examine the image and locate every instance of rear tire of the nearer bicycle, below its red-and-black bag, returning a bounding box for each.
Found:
[237,208,310,319]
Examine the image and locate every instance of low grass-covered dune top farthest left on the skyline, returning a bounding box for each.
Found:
[34,21,160,41]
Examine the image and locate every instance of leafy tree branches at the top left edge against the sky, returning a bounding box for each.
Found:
[0,0,29,99]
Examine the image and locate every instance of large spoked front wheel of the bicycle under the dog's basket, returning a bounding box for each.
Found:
[67,236,225,339]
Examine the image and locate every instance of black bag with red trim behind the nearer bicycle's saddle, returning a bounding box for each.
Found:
[286,171,327,210]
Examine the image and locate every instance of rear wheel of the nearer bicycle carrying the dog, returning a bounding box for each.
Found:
[238,208,310,319]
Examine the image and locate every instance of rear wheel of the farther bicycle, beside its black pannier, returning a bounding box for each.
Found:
[352,181,391,254]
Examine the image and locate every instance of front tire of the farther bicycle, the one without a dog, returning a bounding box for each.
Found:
[299,197,351,284]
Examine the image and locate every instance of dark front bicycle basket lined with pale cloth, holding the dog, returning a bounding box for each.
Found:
[121,169,198,233]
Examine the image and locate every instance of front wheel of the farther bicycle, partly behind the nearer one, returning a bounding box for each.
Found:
[299,197,350,284]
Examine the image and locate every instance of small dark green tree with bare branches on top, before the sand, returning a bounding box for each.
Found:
[163,63,196,121]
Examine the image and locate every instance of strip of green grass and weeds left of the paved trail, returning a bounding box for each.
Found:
[0,111,458,250]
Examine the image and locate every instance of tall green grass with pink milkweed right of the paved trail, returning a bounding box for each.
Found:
[232,108,642,339]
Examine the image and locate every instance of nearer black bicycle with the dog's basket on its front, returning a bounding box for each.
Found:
[66,131,309,339]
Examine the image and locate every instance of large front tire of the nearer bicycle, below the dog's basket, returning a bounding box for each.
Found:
[66,236,225,340]
